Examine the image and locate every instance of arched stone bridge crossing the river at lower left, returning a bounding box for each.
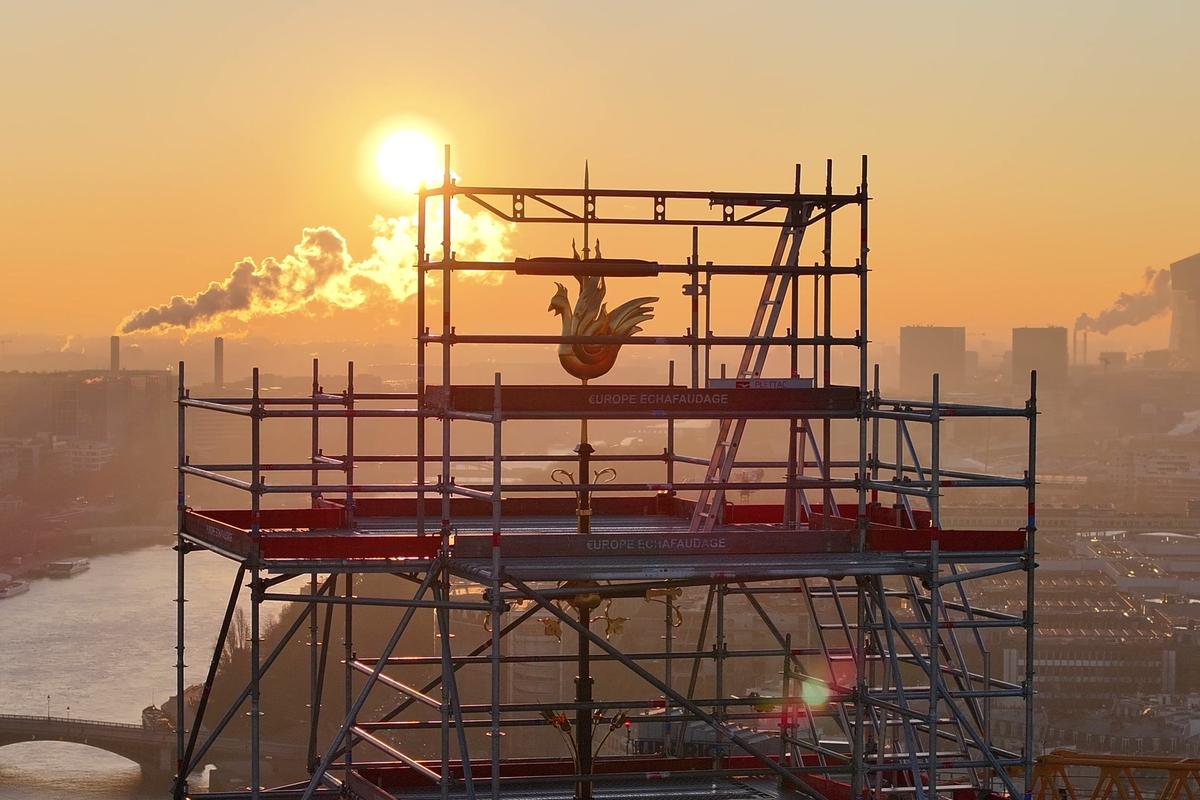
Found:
[0,714,306,775]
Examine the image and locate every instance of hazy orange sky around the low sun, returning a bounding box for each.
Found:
[0,0,1200,347]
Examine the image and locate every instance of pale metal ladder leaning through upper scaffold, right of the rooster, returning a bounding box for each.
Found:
[688,204,812,534]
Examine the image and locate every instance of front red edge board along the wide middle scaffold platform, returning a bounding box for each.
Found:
[184,509,1025,560]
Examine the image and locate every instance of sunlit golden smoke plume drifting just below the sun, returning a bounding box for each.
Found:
[120,204,511,333]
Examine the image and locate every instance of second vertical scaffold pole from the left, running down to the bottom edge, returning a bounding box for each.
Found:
[250,367,263,800]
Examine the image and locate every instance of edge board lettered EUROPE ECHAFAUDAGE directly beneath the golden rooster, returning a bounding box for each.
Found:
[427,384,859,419]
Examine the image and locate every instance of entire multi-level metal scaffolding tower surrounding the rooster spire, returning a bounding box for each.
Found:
[174,154,1037,800]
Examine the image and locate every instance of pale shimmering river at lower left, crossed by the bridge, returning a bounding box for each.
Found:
[0,545,283,800]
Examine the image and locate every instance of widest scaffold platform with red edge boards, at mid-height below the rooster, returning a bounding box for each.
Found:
[184,497,1025,579]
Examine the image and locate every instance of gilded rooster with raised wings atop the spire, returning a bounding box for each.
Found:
[546,275,658,381]
